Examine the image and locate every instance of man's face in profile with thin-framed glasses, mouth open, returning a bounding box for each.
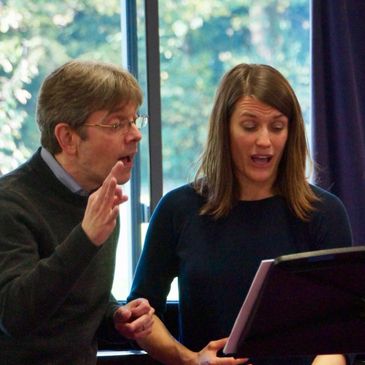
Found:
[72,99,142,191]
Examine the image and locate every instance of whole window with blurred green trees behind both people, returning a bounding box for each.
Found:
[0,0,310,299]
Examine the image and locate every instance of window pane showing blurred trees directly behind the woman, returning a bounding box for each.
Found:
[159,0,310,299]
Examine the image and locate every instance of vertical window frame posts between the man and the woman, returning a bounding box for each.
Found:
[121,0,163,275]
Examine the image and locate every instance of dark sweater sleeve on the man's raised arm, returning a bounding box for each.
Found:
[0,199,98,337]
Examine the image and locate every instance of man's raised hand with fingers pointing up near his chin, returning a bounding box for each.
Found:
[81,161,128,246]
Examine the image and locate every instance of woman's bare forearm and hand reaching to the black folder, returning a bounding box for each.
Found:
[137,315,247,365]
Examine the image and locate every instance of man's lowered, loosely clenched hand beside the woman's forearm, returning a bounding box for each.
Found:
[113,298,155,340]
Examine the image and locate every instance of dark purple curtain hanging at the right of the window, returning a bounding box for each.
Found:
[311,0,365,244]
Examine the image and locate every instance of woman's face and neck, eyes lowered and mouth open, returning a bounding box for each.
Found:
[229,96,288,200]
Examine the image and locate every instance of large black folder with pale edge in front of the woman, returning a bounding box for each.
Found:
[223,246,365,357]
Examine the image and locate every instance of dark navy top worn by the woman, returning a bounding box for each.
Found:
[128,185,352,365]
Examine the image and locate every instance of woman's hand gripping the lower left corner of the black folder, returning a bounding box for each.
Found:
[197,338,248,365]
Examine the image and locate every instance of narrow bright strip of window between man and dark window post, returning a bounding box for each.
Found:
[113,0,150,300]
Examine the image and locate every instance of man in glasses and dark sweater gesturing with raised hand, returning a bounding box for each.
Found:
[0,60,154,365]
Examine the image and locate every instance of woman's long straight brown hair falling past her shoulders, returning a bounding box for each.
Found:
[193,64,318,221]
